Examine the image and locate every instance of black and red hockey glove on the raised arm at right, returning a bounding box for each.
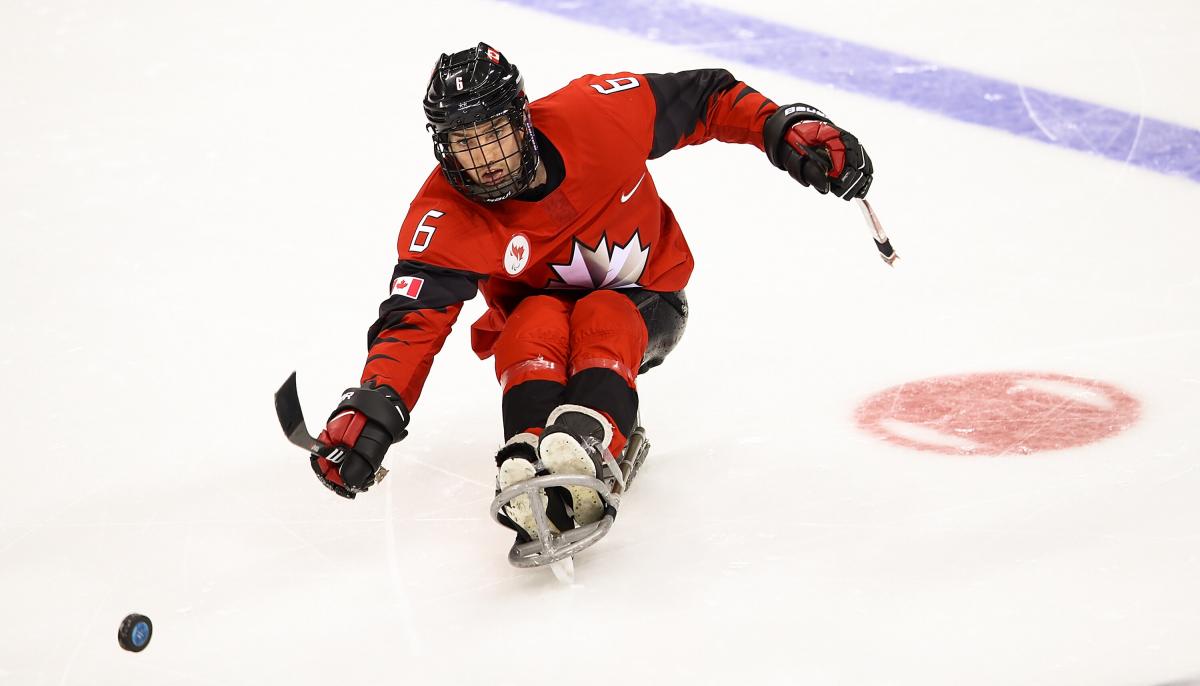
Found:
[762,103,875,200]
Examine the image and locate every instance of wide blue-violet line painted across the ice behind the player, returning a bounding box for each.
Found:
[504,0,1200,181]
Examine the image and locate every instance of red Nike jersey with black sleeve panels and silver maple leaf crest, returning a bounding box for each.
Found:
[362,70,778,408]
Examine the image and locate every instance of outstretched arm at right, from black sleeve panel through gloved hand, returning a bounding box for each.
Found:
[644,68,874,200]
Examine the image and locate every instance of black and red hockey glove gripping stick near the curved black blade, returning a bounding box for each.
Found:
[308,386,408,499]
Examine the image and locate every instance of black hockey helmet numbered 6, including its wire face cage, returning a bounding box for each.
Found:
[425,43,540,203]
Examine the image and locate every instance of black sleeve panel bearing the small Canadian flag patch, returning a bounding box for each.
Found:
[367,260,484,349]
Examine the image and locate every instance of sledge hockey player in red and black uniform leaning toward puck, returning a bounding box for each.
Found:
[311,43,872,542]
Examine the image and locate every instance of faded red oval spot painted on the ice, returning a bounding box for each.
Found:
[856,372,1141,455]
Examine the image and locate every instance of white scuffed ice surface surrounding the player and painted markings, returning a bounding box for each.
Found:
[0,0,1200,686]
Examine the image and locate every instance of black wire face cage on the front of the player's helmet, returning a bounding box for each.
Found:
[428,94,540,203]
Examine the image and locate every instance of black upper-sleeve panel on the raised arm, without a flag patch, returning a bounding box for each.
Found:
[644,70,738,160]
